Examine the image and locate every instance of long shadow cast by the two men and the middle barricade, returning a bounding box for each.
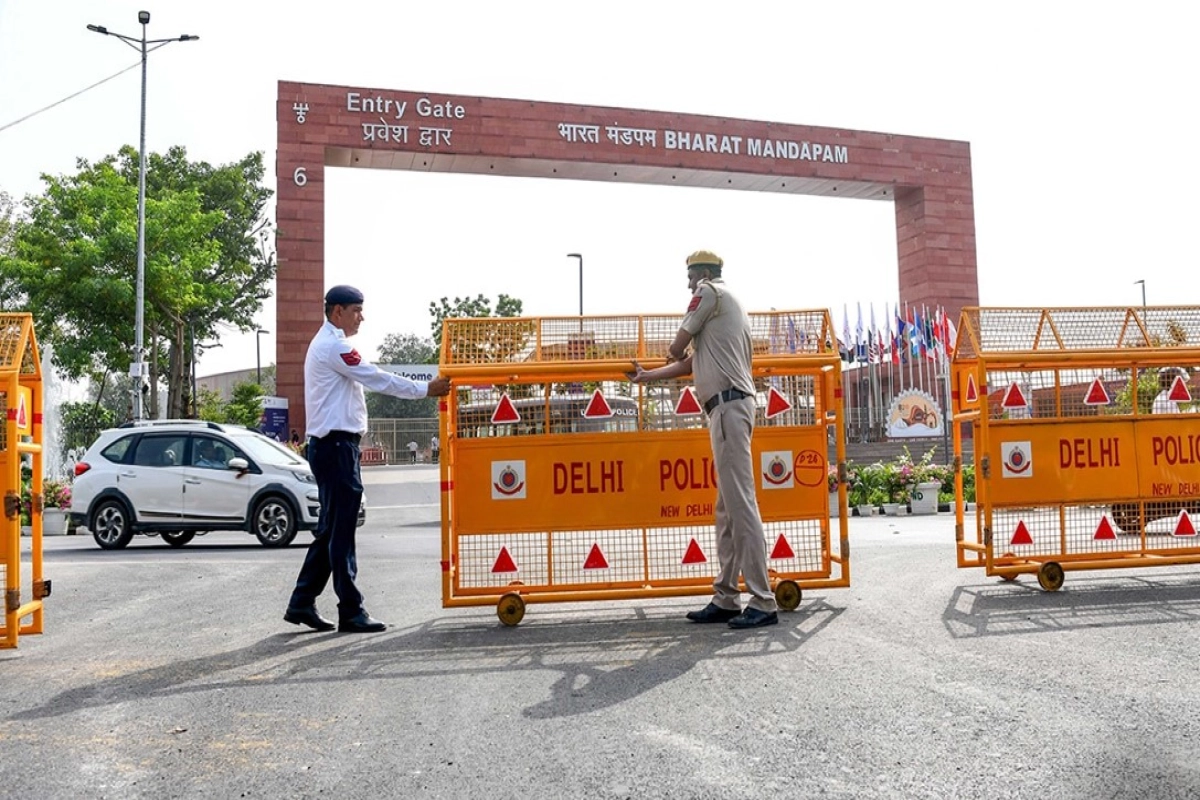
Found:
[6,599,844,721]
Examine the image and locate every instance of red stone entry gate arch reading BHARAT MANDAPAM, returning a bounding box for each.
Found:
[275,80,979,428]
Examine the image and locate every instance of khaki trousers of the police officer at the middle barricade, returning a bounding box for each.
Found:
[708,397,776,612]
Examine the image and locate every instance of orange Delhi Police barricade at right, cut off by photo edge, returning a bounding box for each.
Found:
[952,307,1200,591]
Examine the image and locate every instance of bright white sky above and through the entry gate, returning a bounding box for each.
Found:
[0,0,1200,375]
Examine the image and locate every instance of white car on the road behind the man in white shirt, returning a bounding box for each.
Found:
[71,420,366,549]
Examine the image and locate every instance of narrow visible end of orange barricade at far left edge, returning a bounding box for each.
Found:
[0,313,50,648]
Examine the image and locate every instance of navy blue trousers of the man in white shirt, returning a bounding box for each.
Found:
[289,433,364,620]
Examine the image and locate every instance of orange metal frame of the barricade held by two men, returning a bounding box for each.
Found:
[439,311,850,625]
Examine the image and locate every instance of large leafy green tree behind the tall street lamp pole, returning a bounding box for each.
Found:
[0,148,275,416]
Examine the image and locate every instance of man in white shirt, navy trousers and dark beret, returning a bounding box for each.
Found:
[283,285,450,633]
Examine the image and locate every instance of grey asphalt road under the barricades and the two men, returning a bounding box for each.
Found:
[0,467,1200,800]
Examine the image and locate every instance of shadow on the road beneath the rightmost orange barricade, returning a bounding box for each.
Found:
[942,573,1200,638]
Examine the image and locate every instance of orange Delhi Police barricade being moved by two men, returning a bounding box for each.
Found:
[440,311,850,625]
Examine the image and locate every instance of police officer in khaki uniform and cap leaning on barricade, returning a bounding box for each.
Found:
[629,249,779,628]
